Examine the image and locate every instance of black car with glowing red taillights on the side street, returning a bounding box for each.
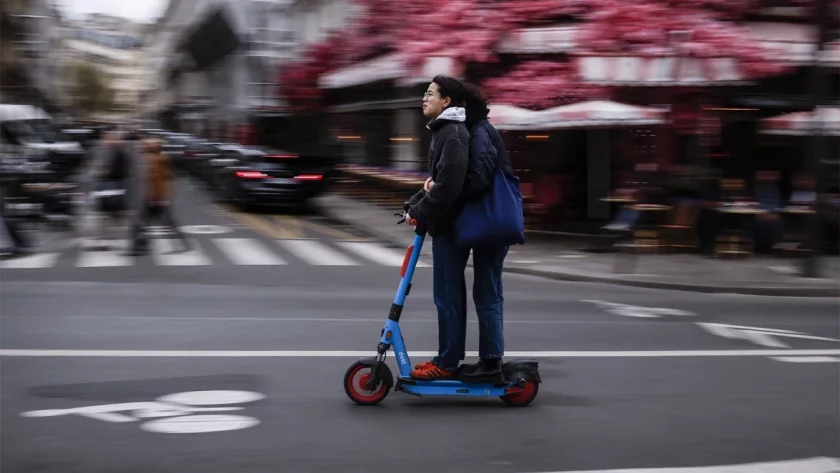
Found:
[213,145,329,207]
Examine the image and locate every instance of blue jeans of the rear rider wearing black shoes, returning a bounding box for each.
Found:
[473,246,509,360]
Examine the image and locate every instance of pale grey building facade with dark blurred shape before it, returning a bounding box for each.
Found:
[143,0,352,139]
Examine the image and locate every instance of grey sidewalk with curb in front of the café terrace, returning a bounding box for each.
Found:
[314,194,840,297]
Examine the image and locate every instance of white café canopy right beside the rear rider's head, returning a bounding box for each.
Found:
[489,100,668,130]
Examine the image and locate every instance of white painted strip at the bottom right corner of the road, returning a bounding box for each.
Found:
[536,457,840,473]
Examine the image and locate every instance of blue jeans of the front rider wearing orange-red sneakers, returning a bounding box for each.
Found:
[432,235,470,370]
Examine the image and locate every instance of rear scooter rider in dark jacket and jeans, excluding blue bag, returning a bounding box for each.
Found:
[460,83,514,378]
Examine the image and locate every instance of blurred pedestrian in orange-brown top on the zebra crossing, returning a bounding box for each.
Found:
[129,139,189,256]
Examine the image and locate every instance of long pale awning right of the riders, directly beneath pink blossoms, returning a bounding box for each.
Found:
[577,54,749,87]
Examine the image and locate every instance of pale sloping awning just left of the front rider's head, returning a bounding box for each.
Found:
[318,53,459,89]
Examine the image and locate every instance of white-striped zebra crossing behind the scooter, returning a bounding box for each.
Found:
[0,237,431,271]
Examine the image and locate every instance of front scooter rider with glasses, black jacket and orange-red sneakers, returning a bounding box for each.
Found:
[405,76,470,380]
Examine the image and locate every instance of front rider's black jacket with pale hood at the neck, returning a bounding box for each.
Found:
[407,109,470,237]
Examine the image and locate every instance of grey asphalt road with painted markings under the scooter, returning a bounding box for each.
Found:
[0,178,840,473]
